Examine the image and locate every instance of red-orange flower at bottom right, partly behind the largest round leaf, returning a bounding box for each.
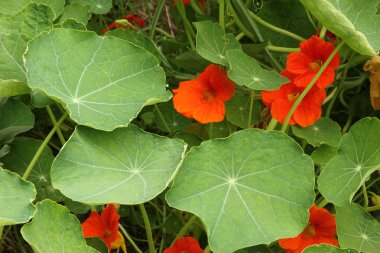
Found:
[278,204,338,253]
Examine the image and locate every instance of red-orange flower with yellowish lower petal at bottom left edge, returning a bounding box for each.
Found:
[82,204,127,252]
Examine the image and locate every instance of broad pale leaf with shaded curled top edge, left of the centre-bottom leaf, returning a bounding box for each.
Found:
[51,125,186,204]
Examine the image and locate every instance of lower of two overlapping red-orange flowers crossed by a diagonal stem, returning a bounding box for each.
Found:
[261,70,326,127]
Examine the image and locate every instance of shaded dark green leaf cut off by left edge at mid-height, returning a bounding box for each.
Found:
[0,98,34,144]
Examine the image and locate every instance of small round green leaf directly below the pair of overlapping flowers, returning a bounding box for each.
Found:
[292,117,341,147]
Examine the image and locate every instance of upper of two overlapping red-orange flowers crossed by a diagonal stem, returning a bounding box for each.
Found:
[286,36,340,89]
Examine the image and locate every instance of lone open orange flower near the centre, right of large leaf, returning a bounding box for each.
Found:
[173,64,235,124]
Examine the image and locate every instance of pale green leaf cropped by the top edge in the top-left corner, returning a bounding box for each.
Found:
[0,0,65,19]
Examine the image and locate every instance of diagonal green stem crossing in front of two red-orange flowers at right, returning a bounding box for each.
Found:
[281,41,344,132]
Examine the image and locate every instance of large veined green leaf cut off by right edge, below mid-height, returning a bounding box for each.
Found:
[318,118,380,206]
